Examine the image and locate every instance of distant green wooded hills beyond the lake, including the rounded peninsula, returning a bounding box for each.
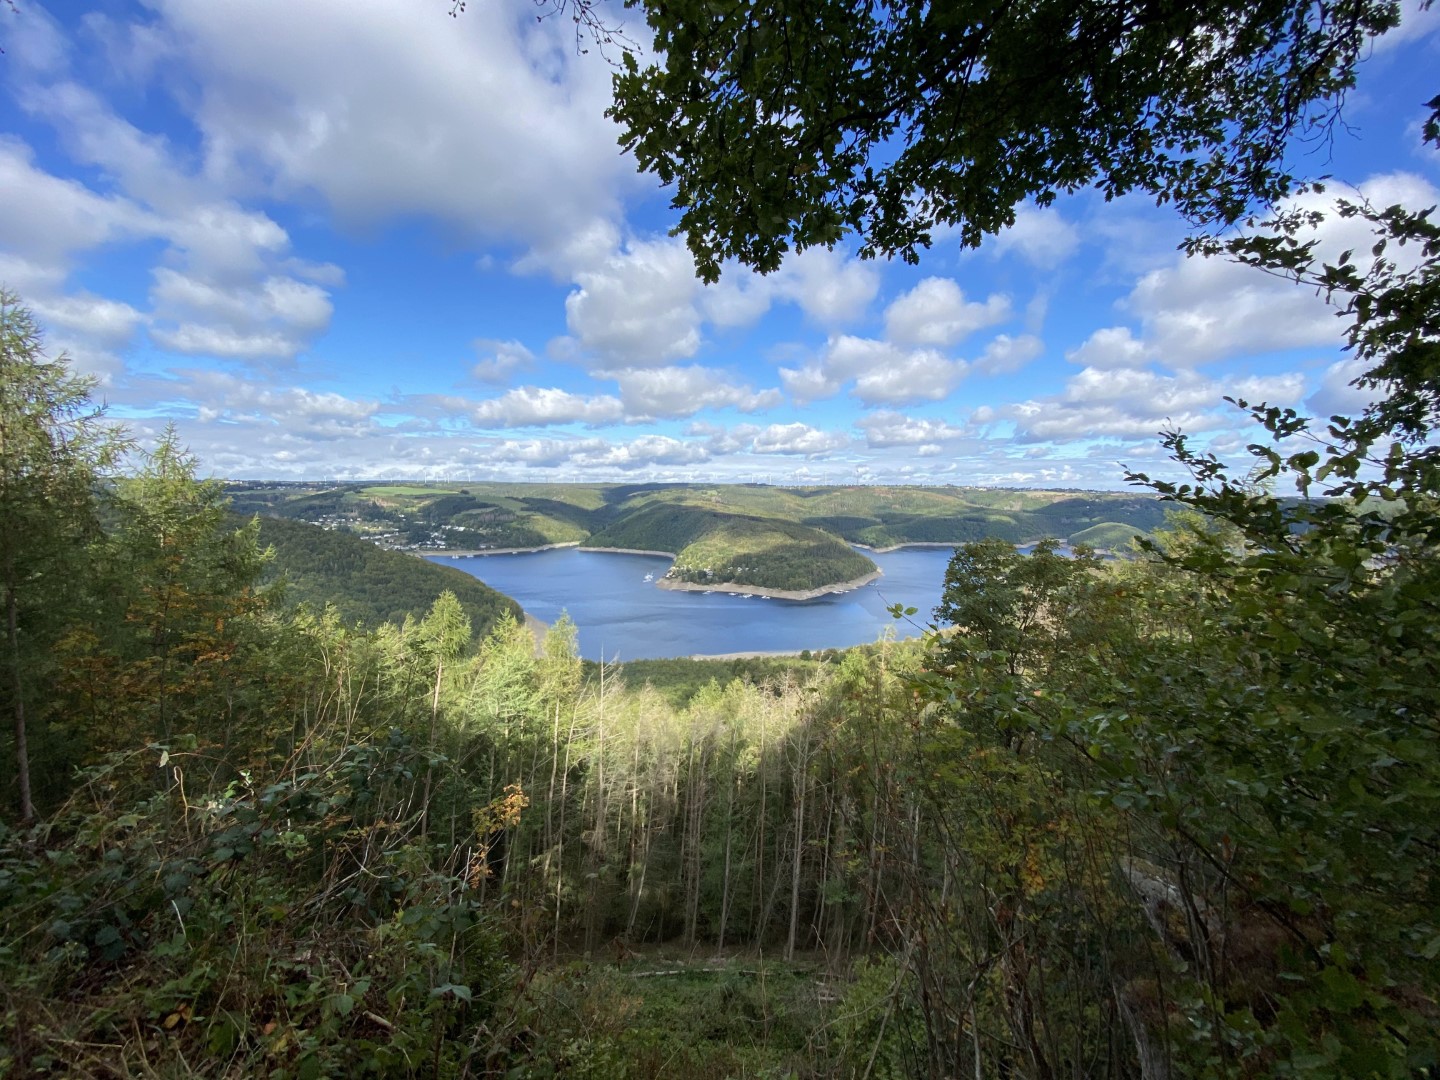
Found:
[228,482,1164,599]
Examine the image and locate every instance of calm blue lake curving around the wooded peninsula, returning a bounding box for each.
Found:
[426,547,952,661]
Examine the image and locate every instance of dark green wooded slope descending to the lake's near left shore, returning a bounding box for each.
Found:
[259,517,523,635]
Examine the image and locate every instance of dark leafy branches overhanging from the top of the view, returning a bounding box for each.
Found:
[610,0,1400,281]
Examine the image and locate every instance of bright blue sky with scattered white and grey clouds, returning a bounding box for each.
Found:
[0,0,1440,488]
